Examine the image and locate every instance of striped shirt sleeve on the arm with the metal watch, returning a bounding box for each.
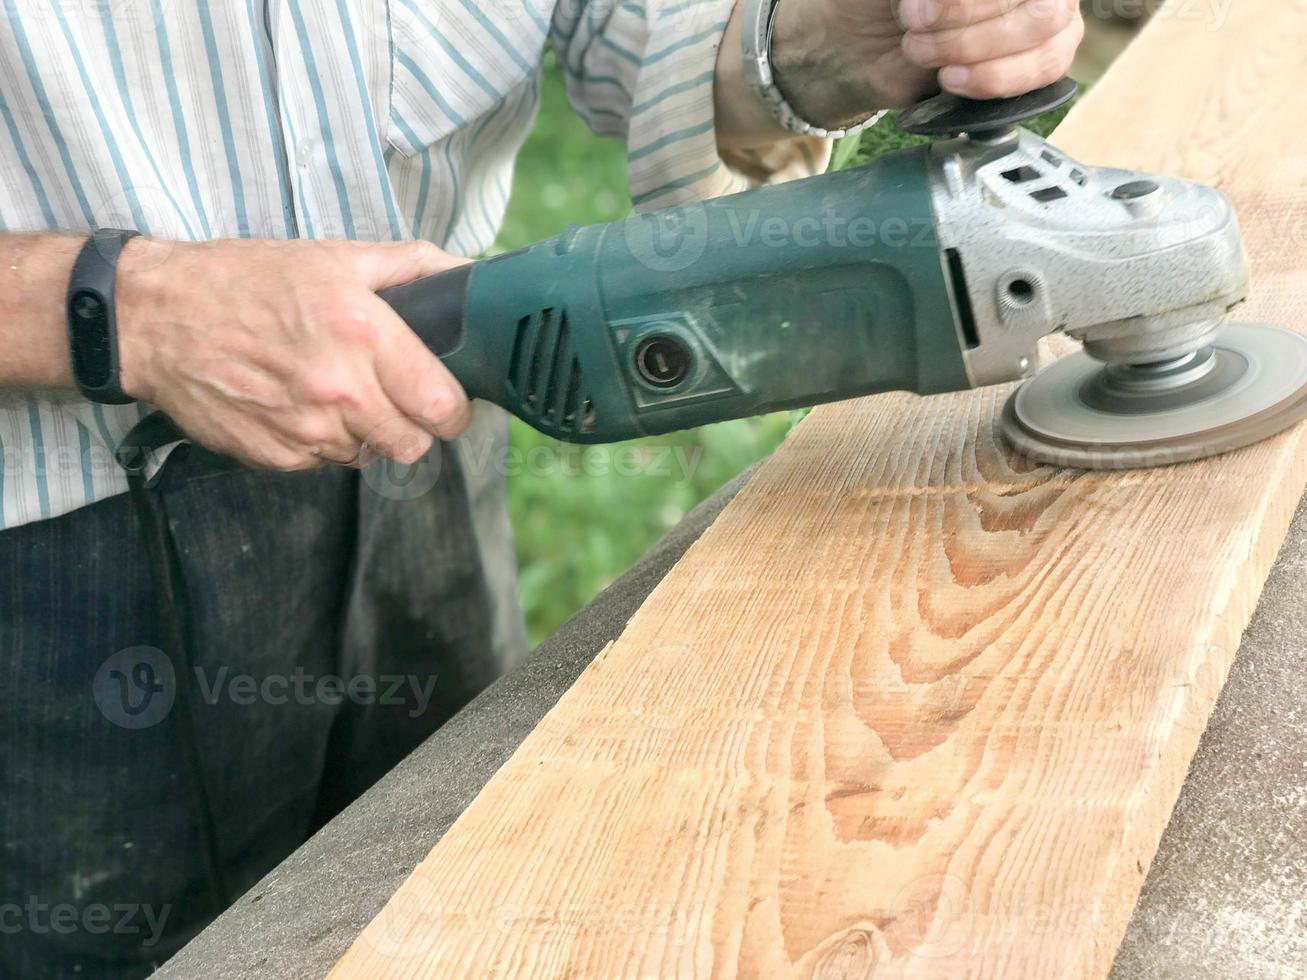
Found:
[550,0,830,210]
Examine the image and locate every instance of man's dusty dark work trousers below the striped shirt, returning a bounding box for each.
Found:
[0,402,523,980]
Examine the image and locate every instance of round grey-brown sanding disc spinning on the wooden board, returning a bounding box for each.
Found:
[1001,323,1307,469]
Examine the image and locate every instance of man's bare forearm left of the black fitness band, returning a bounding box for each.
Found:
[0,234,86,388]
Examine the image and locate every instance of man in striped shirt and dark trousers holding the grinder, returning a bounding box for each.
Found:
[0,0,1082,977]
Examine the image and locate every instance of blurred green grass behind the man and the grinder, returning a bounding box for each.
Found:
[495,67,1063,643]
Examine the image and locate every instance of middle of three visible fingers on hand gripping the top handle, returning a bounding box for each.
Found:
[903,0,1080,69]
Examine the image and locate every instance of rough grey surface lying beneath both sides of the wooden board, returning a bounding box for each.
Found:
[156,473,1307,980]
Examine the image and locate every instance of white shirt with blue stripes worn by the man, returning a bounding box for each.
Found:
[0,0,825,528]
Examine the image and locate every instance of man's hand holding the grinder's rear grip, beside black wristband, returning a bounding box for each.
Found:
[115,238,469,469]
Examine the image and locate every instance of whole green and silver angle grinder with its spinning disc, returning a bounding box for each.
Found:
[380,78,1307,469]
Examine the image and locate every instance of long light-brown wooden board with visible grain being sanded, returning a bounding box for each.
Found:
[333,0,1307,979]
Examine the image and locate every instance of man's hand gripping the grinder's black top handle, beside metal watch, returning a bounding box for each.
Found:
[772,0,1085,128]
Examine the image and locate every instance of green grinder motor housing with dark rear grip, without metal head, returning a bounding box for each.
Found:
[382,148,970,443]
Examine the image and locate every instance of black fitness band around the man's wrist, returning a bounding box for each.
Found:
[67,229,139,405]
